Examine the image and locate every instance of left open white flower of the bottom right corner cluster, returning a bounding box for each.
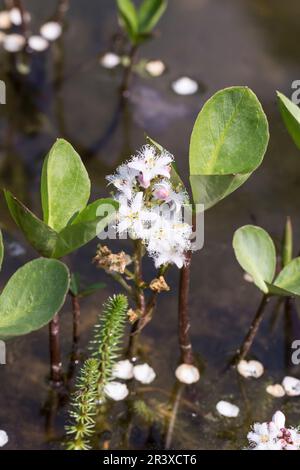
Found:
[247,423,282,450]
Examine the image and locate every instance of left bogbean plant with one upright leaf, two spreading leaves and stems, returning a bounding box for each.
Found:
[4,139,117,383]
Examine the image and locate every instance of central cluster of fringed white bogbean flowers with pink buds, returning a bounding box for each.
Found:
[107,145,192,268]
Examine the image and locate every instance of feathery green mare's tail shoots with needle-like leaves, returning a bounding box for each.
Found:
[66,295,128,450]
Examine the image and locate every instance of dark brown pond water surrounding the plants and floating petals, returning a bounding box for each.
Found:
[0,0,300,449]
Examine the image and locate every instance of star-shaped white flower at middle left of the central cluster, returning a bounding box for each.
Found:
[117,192,157,239]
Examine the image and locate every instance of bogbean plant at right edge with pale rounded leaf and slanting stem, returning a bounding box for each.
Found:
[233,220,300,362]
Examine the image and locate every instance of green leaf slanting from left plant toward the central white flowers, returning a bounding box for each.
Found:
[52,199,118,258]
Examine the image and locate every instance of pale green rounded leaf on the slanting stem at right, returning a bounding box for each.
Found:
[233,225,276,294]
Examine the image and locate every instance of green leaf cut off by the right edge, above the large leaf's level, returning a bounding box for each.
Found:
[277,91,300,149]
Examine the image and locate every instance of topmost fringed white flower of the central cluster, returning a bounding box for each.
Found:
[128,145,173,189]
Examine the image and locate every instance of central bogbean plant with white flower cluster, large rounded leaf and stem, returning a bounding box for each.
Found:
[96,87,269,381]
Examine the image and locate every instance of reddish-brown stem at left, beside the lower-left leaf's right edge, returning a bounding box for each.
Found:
[49,314,62,386]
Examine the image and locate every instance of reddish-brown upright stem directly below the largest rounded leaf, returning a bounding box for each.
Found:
[178,251,194,364]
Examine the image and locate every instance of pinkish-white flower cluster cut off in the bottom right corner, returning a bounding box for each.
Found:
[247,411,300,450]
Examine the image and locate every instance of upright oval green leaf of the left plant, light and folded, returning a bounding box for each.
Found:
[41,139,91,232]
